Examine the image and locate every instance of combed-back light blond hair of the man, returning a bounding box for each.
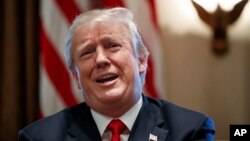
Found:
[65,7,149,84]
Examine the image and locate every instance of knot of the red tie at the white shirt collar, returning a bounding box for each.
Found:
[107,119,127,136]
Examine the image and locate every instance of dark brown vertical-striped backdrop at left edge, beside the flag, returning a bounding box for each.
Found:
[0,0,39,141]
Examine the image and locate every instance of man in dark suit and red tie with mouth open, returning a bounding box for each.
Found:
[19,8,215,141]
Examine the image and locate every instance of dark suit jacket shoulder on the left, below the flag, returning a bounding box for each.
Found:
[19,103,87,140]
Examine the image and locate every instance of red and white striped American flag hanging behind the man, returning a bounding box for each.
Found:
[39,0,164,117]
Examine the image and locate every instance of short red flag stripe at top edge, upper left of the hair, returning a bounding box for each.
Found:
[55,0,80,23]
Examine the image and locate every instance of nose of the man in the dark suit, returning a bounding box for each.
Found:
[95,47,110,68]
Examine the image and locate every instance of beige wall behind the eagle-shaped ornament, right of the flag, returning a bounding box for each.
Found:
[157,0,250,140]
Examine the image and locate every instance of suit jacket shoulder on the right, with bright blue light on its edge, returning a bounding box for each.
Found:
[146,98,215,140]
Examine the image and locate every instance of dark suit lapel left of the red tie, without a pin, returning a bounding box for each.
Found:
[65,104,101,141]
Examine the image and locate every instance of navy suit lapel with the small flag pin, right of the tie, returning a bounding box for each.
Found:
[129,96,169,141]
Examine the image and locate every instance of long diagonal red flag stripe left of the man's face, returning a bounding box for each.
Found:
[40,23,77,106]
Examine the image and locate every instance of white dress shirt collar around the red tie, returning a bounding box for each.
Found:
[91,96,142,141]
